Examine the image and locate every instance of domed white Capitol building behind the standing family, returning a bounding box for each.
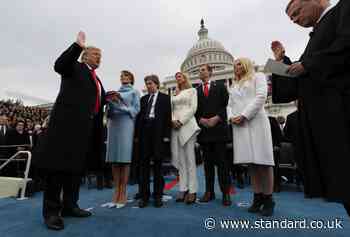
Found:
[162,19,295,117]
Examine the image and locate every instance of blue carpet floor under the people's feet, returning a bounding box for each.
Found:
[0,167,350,237]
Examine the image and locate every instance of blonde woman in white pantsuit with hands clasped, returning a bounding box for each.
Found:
[171,72,199,204]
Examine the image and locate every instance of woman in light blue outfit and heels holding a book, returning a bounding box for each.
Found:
[106,71,140,208]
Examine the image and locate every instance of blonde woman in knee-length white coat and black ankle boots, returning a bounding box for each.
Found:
[227,58,275,216]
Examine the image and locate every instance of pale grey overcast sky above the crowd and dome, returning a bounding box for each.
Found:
[0,0,337,104]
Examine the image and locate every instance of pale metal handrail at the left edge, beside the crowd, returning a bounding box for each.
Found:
[0,145,32,200]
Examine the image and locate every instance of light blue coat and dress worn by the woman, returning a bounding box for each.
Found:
[106,85,140,163]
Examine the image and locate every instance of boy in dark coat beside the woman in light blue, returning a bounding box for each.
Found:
[137,75,171,208]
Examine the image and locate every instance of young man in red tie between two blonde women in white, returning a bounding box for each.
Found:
[195,64,231,206]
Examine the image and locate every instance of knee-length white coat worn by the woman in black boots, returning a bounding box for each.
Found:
[227,74,274,166]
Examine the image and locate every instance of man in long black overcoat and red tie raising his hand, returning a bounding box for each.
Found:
[34,32,113,230]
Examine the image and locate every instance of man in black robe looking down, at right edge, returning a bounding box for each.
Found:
[273,0,350,215]
